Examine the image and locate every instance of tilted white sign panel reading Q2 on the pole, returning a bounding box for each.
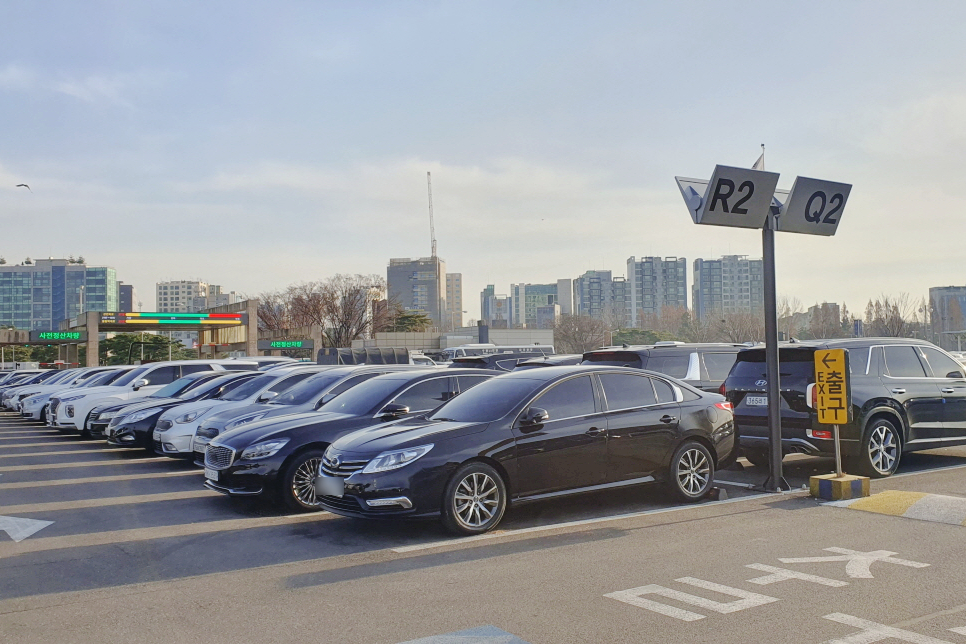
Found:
[778,177,852,237]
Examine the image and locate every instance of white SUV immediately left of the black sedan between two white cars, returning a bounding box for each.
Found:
[48,360,256,434]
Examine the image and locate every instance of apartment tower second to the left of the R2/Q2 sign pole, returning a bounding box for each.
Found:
[627,256,688,327]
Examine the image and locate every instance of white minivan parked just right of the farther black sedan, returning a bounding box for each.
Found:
[154,363,331,458]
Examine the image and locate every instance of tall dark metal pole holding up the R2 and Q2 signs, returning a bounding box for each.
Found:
[761,214,790,492]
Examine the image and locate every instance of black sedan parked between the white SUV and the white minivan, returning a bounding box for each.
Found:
[103,371,259,451]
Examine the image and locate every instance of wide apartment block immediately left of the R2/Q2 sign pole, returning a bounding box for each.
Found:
[691,255,765,319]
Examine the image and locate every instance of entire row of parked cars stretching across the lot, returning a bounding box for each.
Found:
[0,338,966,534]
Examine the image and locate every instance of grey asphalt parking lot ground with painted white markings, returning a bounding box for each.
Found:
[0,414,966,644]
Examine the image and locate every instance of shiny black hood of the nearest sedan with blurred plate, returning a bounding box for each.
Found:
[332,417,490,454]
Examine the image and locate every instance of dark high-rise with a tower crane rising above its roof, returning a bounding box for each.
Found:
[386,257,446,328]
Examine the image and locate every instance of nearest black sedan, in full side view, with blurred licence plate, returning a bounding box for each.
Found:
[316,366,737,534]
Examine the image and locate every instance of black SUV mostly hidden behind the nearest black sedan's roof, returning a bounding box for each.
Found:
[581,342,748,393]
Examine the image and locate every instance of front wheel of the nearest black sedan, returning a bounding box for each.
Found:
[442,462,507,535]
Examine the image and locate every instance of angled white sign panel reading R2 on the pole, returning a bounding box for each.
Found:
[675,165,778,228]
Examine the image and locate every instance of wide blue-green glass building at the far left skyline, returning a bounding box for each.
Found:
[0,258,118,331]
